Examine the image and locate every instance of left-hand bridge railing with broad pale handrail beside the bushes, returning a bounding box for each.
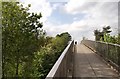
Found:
[46,41,74,79]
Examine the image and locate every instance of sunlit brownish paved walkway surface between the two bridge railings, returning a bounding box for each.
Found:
[74,44,119,79]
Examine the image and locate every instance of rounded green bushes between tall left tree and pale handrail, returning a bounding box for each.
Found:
[32,32,71,79]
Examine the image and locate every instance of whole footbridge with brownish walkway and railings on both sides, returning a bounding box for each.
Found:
[46,40,120,79]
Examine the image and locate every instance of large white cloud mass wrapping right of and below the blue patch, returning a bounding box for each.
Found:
[48,0,118,41]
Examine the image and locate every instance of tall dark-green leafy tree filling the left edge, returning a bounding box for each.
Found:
[2,2,42,77]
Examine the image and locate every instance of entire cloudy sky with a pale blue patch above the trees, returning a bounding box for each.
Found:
[20,0,119,42]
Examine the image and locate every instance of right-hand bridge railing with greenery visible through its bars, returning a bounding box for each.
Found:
[81,40,120,72]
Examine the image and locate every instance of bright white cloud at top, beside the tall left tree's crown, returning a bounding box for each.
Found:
[20,0,52,22]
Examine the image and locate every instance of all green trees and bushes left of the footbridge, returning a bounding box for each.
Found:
[2,2,71,79]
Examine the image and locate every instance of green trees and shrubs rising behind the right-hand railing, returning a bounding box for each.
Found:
[94,26,120,44]
